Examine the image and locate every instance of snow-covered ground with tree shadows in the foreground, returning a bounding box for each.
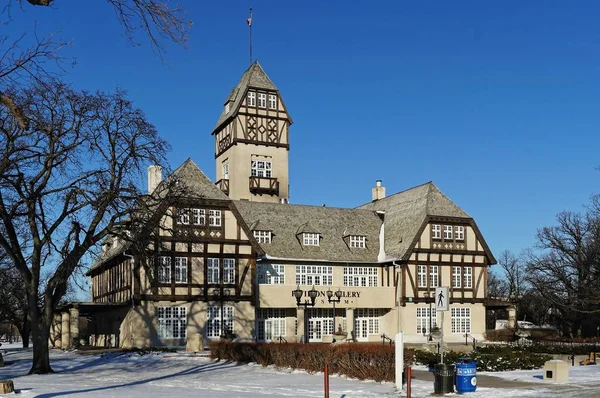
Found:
[0,344,600,398]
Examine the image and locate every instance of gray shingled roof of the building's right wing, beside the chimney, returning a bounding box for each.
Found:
[358,182,471,259]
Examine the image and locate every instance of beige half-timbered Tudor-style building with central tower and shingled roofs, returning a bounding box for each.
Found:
[55,62,495,347]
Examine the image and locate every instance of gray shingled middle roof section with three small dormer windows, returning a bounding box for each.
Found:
[233,200,381,263]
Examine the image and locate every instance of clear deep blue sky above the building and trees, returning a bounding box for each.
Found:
[8,0,600,262]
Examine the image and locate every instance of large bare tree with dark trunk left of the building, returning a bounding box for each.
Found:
[0,81,168,373]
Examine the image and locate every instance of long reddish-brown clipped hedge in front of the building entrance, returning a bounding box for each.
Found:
[210,341,415,382]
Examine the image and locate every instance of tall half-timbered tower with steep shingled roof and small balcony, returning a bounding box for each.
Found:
[212,61,292,203]
